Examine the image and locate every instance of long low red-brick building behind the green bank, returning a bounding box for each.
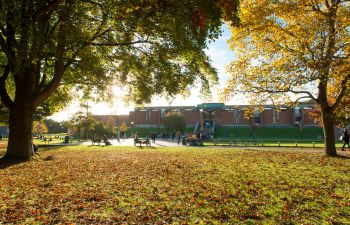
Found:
[125,103,317,127]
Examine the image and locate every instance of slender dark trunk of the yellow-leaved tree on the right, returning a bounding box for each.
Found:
[322,109,337,156]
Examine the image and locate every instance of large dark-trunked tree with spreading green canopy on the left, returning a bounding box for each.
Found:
[0,0,238,160]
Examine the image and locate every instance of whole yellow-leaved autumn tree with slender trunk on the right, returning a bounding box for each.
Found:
[225,0,350,156]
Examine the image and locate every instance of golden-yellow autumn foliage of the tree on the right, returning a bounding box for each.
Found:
[224,0,350,108]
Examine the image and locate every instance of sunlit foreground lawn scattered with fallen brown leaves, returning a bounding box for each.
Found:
[0,147,350,224]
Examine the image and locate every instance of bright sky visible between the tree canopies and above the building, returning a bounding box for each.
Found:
[51,24,239,121]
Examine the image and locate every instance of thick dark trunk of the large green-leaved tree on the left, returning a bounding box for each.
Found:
[4,107,34,160]
